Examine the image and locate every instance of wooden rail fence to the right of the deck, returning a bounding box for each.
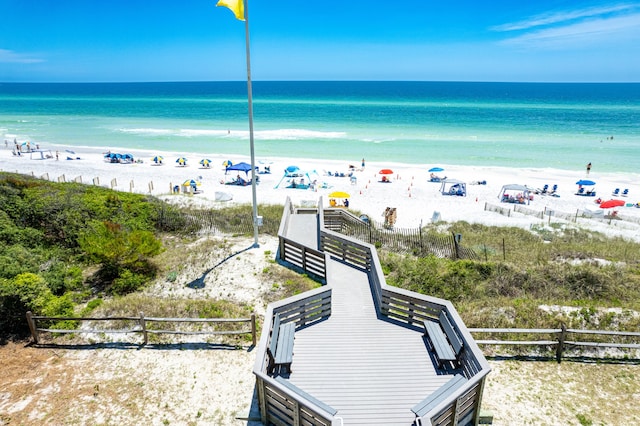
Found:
[468,324,640,363]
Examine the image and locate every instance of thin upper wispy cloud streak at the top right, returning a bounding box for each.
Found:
[490,4,640,32]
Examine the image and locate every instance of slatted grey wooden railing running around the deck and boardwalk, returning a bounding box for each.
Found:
[264,199,490,425]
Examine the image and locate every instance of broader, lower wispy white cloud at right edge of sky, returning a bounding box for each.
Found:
[502,13,640,48]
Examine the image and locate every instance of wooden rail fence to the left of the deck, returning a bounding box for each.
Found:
[27,311,257,346]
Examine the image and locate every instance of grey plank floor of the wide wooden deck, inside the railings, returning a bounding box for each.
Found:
[290,255,451,425]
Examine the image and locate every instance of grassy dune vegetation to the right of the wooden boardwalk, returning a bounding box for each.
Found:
[379,222,640,331]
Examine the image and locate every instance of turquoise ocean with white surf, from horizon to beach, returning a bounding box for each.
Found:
[0,81,640,173]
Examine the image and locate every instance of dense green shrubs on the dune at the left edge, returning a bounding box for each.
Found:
[0,173,161,337]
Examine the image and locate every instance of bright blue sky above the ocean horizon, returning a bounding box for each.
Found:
[0,0,640,82]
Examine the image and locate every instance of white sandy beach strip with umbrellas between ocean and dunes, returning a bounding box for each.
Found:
[0,146,640,240]
